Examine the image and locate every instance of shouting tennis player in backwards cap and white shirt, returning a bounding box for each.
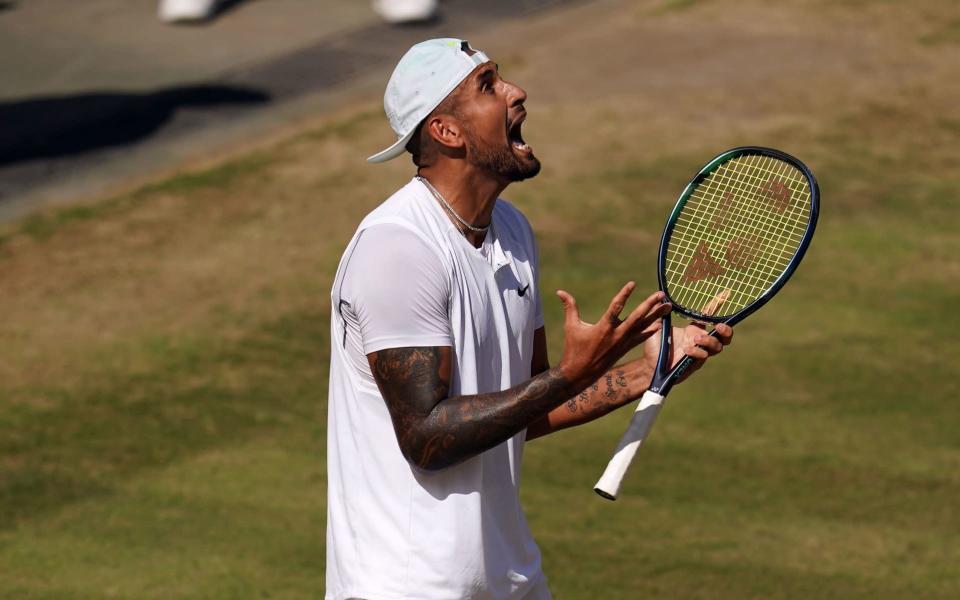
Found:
[326,39,732,600]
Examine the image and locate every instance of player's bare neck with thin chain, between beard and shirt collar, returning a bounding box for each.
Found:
[417,165,507,247]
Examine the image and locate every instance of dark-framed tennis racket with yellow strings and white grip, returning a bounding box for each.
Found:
[594,146,820,500]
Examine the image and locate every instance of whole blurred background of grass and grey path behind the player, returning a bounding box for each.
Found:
[0,0,960,600]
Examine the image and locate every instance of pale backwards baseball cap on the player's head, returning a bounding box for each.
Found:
[367,38,490,162]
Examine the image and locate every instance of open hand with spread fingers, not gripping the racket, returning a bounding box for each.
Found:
[557,281,673,389]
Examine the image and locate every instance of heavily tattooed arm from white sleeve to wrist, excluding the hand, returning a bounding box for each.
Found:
[371,348,576,469]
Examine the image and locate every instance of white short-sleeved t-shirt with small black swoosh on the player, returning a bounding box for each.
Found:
[326,179,549,600]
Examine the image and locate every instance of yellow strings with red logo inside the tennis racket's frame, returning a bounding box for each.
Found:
[666,155,810,316]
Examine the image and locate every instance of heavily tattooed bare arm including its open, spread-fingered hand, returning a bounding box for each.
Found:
[367,282,670,469]
